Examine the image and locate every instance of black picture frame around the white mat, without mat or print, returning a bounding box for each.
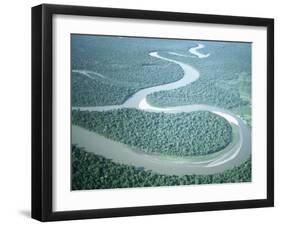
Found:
[32,4,274,221]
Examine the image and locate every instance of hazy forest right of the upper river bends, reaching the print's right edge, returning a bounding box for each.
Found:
[147,42,251,126]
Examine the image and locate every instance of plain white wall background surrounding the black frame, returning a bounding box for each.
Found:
[0,0,276,226]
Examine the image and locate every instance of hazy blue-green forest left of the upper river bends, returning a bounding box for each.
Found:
[71,35,183,106]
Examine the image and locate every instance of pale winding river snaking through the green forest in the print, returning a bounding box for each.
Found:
[72,44,251,176]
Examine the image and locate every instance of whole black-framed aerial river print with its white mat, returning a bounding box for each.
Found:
[32,4,274,221]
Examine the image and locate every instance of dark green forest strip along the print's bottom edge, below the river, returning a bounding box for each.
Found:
[72,145,251,190]
